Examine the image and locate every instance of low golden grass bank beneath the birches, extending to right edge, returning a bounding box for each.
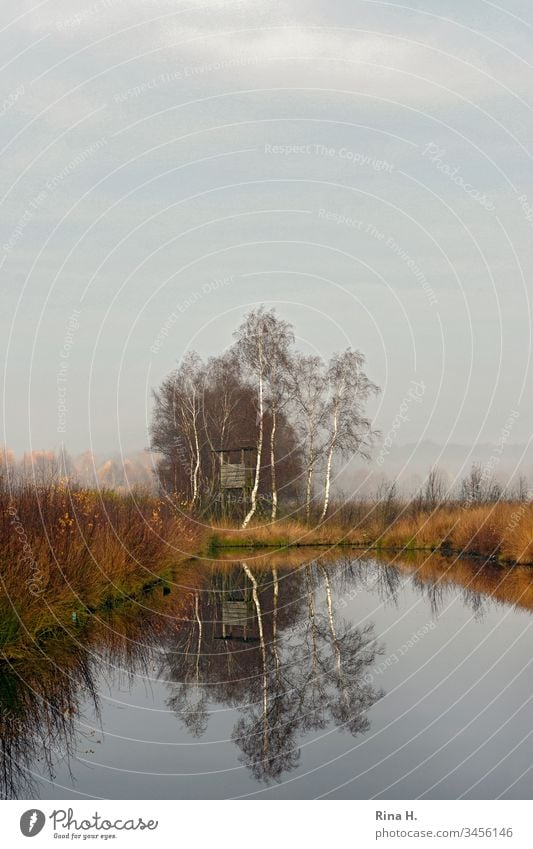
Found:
[209,502,533,565]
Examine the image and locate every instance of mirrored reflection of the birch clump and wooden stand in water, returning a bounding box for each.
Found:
[162,562,382,780]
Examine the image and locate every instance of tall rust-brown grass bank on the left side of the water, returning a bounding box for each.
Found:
[0,485,197,655]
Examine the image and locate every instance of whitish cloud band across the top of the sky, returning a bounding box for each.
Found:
[21,0,530,112]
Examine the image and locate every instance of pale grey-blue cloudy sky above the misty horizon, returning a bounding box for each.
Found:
[0,0,533,476]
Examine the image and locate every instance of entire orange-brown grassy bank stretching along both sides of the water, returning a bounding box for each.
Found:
[4,485,533,656]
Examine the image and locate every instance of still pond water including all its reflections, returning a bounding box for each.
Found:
[0,552,533,799]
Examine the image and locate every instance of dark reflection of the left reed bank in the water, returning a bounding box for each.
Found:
[0,567,201,798]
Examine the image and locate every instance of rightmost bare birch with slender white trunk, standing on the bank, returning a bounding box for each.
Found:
[320,348,379,522]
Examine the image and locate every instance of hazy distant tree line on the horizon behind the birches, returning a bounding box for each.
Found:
[0,448,533,525]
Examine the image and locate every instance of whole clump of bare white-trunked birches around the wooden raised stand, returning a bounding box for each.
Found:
[151,306,378,516]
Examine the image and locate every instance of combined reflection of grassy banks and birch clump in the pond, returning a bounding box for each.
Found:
[0,551,516,798]
